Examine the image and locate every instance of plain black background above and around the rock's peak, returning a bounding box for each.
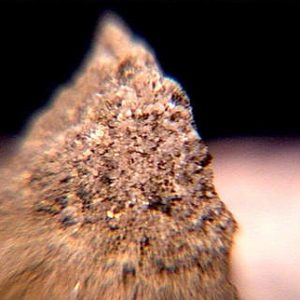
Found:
[0,0,300,139]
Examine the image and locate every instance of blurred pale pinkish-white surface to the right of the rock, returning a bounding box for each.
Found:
[208,138,300,300]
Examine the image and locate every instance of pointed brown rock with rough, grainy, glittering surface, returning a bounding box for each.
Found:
[0,14,237,300]
